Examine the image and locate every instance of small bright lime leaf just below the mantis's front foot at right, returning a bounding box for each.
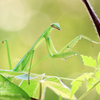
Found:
[81,55,97,68]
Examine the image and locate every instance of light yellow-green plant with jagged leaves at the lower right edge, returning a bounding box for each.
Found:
[71,53,100,100]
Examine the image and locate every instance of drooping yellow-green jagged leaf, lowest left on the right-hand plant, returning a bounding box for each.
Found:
[70,73,93,99]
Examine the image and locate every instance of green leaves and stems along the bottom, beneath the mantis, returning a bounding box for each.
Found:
[0,53,100,100]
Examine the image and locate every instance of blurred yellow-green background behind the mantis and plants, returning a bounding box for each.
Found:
[0,0,100,100]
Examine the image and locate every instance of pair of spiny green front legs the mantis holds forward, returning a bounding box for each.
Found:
[45,35,99,64]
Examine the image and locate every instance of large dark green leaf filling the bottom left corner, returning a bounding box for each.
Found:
[0,74,31,100]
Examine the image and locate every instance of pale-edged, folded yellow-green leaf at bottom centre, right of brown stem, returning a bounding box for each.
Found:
[41,77,76,100]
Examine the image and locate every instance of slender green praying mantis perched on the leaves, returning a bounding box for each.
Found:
[0,0,99,80]
